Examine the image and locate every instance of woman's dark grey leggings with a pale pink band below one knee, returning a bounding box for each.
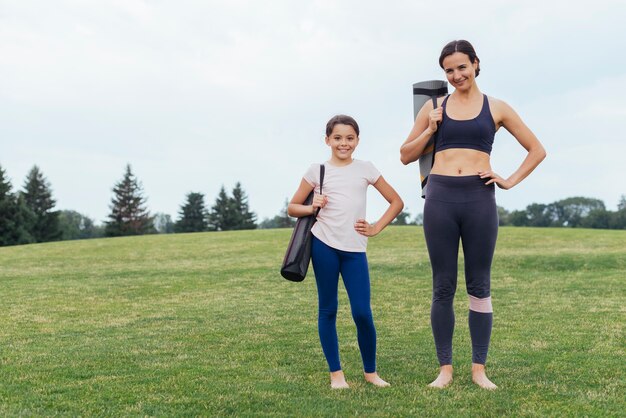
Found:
[424,174,498,366]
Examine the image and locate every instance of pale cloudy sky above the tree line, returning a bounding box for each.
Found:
[0,0,626,222]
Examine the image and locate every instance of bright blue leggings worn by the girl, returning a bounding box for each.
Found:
[311,236,376,373]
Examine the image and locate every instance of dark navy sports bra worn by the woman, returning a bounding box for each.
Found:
[435,95,496,154]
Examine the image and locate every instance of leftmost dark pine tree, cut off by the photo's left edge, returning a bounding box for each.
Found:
[0,167,34,246]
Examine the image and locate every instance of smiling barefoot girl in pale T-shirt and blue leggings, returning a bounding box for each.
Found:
[288,115,404,389]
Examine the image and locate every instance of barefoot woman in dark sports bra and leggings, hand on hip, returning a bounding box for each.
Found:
[400,40,546,389]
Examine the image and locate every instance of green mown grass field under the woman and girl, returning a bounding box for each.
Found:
[0,227,626,416]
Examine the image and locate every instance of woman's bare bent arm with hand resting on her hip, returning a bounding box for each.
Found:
[478,100,546,190]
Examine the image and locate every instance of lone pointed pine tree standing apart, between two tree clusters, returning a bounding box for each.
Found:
[105,164,154,237]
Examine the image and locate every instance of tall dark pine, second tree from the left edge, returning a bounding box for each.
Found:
[22,165,61,242]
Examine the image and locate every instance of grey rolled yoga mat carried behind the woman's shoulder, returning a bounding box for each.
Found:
[413,80,448,197]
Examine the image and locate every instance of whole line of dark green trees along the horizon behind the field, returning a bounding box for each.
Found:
[0,164,626,246]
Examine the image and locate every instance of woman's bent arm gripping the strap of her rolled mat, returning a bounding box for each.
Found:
[400,100,443,165]
